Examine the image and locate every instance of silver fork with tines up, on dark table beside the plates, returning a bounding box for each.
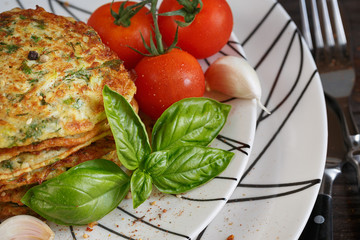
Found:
[300,0,360,191]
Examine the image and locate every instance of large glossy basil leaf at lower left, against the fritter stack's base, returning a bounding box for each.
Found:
[21,159,130,225]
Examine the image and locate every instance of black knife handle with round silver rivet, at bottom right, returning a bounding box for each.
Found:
[299,194,333,240]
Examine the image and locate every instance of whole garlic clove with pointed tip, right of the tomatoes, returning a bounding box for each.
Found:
[205,56,270,114]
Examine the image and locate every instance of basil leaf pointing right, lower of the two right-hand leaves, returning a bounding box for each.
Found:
[151,146,234,194]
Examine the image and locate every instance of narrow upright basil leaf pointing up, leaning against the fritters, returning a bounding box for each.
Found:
[103,86,151,170]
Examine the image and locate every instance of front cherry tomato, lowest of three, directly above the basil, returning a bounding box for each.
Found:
[135,48,205,119]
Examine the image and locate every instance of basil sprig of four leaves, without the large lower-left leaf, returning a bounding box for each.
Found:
[103,86,234,208]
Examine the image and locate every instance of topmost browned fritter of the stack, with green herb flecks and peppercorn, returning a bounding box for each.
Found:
[0,7,135,148]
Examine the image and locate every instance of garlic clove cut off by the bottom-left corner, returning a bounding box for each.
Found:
[0,215,55,240]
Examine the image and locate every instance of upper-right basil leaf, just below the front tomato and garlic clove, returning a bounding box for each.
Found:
[152,98,231,151]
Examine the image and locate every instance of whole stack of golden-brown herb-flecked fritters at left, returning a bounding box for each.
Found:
[0,7,136,218]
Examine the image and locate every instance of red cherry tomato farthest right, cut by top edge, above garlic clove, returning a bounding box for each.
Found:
[158,0,233,59]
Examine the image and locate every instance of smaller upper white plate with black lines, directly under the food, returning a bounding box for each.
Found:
[0,0,257,240]
